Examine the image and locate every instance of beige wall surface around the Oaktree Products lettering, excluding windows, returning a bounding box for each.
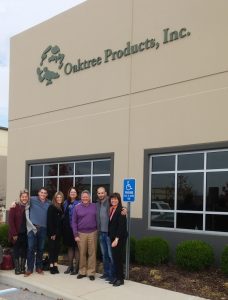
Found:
[7,0,228,218]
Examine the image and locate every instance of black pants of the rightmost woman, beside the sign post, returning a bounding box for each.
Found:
[112,240,126,280]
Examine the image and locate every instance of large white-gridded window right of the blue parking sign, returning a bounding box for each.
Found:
[149,150,228,232]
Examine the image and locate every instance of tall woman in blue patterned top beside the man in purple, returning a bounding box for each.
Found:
[63,186,80,275]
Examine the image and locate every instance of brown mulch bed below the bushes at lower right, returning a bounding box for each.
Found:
[129,264,228,300]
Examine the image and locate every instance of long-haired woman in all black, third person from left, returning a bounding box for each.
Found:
[47,192,64,274]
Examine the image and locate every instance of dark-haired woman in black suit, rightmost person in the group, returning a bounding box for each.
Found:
[109,193,127,286]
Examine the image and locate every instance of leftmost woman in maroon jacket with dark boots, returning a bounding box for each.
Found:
[9,190,29,275]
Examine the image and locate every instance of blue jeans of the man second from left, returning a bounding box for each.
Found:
[27,227,47,272]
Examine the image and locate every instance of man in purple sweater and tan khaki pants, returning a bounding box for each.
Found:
[72,190,97,280]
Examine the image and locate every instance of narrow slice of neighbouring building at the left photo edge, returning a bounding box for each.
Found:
[0,127,8,206]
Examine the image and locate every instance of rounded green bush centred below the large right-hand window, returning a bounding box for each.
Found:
[176,240,214,271]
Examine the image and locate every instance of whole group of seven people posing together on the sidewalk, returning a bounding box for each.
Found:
[9,187,127,286]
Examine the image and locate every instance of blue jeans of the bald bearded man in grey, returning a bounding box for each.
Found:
[99,232,115,280]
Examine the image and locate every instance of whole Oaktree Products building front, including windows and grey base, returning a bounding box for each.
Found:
[7,0,228,255]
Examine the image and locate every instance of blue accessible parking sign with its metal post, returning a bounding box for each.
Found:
[123,178,135,279]
